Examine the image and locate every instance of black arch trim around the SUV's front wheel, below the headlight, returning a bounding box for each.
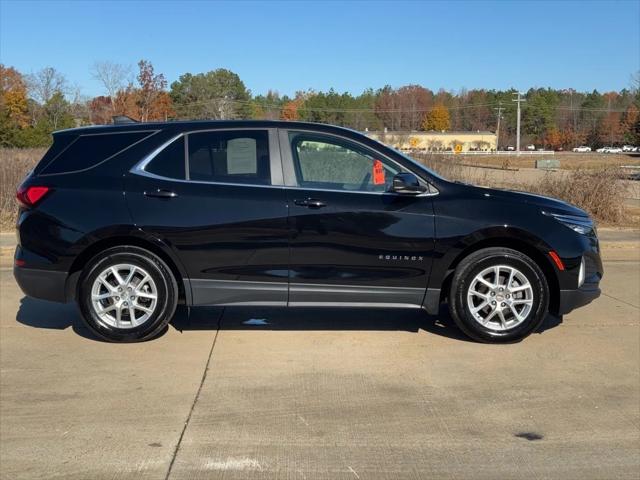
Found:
[440,236,560,312]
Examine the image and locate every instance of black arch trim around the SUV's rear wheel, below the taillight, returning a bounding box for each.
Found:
[65,235,191,303]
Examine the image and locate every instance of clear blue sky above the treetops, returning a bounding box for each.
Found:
[0,0,640,95]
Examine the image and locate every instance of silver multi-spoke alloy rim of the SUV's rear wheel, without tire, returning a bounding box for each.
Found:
[91,263,158,329]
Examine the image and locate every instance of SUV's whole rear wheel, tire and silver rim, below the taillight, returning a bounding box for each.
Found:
[77,246,178,342]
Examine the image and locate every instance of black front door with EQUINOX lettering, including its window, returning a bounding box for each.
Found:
[280,131,434,305]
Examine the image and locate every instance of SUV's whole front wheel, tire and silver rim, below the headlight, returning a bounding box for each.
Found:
[449,248,549,343]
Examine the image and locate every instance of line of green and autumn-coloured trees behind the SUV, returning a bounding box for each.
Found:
[0,60,640,149]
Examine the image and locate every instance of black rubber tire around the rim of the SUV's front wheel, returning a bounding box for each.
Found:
[449,247,549,343]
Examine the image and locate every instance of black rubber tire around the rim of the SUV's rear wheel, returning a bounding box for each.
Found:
[76,246,178,342]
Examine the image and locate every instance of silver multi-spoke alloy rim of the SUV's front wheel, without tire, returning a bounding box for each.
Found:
[467,265,533,332]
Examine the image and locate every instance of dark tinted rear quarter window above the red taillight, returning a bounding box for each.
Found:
[43,132,153,174]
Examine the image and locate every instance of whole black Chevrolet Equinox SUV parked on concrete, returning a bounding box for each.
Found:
[14,121,603,342]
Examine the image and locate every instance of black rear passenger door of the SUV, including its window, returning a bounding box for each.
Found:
[126,128,288,305]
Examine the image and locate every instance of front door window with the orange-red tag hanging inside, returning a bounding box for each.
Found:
[289,132,402,192]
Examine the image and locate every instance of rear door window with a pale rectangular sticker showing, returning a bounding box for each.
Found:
[189,130,271,185]
